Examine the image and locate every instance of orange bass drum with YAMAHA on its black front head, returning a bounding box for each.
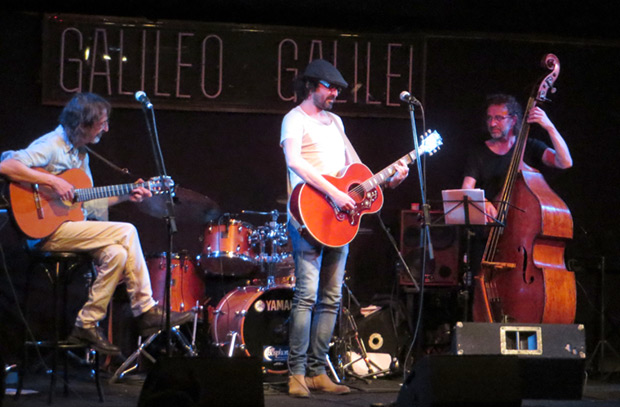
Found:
[211,286,293,374]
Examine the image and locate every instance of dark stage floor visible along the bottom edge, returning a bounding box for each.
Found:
[3,368,620,407]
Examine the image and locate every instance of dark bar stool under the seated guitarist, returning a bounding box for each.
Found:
[15,251,104,404]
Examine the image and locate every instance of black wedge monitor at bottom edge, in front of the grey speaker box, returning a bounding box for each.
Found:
[396,355,521,407]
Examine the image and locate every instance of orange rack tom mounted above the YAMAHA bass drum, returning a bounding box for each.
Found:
[199,219,256,276]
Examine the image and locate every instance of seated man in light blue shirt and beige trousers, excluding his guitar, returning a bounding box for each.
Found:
[0,93,192,354]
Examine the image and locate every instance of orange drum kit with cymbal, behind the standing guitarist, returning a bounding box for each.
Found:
[138,193,295,373]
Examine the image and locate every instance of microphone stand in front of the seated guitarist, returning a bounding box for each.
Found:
[142,103,177,357]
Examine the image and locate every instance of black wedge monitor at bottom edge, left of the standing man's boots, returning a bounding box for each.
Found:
[138,357,265,407]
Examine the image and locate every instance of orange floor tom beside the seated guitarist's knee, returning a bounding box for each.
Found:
[146,252,206,312]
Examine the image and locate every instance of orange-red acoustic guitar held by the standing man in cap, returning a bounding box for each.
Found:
[289,130,443,247]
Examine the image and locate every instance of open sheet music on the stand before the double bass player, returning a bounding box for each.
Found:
[441,188,487,225]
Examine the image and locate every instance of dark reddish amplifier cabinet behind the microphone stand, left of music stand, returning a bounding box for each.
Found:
[399,210,460,286]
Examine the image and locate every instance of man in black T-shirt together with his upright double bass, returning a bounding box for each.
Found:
[463,63,577,323]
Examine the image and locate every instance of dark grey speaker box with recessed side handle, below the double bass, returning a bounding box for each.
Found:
[452,322,586,400]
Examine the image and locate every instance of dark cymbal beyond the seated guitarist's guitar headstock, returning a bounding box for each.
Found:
[138,186,221,224]
